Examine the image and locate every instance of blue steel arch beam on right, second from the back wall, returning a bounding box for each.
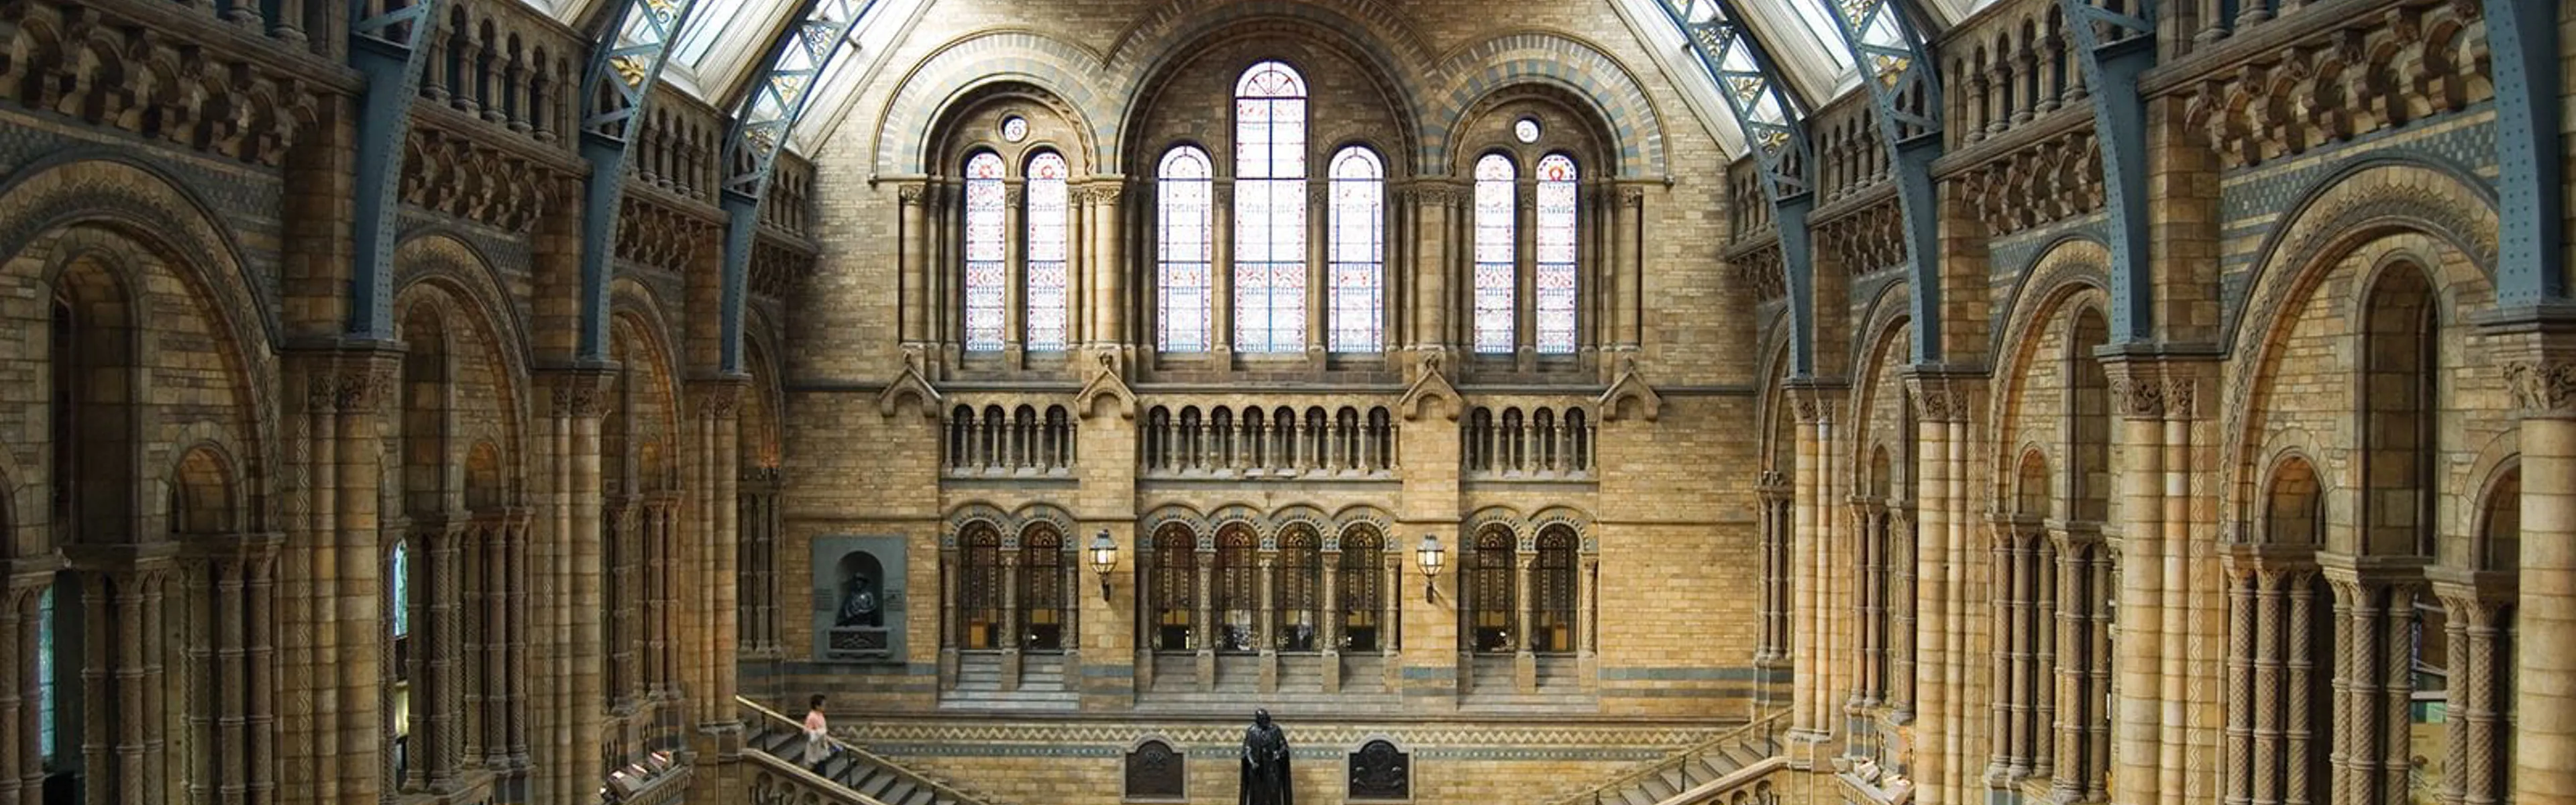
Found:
[1803,0,1942,364]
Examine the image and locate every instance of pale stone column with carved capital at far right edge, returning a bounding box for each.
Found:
[2504,361,2576,802]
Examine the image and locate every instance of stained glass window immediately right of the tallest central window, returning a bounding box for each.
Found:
[1332,144,1386,354]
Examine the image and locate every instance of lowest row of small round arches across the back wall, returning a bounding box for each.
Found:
[941,506,1600,694]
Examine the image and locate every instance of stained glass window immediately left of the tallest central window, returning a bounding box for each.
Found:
[1154,144,1211,354]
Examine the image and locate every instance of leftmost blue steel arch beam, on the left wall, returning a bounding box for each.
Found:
[343,0,443,341]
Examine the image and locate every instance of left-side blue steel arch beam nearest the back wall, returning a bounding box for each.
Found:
[716,0,876,377]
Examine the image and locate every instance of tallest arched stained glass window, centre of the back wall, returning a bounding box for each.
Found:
[1234,62,1306,354]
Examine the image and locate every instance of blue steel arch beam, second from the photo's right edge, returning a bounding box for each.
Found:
[2058,0,2156,343]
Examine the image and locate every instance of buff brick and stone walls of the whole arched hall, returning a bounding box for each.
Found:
[0,0,2576,805]
